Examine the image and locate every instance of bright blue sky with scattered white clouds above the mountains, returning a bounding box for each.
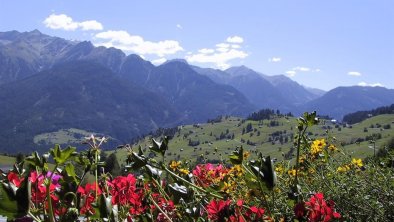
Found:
[0,0,394,90]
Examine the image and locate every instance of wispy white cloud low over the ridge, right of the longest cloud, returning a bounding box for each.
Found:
[185,49,248,69]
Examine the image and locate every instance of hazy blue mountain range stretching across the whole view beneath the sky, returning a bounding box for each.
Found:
[0,30,394,152]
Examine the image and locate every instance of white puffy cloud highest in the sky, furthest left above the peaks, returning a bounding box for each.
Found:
[43,14,103,31]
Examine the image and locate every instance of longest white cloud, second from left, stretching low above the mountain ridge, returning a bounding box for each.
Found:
[95,30,183,57]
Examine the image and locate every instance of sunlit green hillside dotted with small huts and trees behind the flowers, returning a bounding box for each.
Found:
[117,114,394,163]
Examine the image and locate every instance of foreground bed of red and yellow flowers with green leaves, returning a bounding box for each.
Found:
[0,113,394,222]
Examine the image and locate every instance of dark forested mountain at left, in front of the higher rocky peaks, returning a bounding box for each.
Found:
[0,61,182,153]
